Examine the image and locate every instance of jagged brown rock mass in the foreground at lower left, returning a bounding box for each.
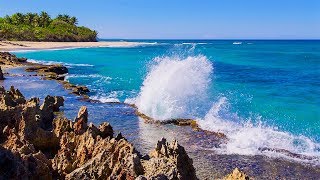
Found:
[0,87,196,179]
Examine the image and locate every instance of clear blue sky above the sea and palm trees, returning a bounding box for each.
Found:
[0,0,320,39]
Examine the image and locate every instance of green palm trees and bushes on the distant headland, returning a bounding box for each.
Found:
[0,12,97,41]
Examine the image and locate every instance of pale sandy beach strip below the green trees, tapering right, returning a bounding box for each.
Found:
[0,41,144,51]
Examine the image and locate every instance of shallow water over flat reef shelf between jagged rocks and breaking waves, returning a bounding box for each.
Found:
[3,63,320,179]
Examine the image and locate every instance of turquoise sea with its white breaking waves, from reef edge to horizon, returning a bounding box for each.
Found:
[15,40,320,162]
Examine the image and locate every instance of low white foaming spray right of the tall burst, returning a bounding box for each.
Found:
[198,97,320,165]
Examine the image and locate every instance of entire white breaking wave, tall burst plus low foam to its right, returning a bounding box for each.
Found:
[133,55,320,165]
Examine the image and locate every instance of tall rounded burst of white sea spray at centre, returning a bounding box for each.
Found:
[135,55,213,120]
